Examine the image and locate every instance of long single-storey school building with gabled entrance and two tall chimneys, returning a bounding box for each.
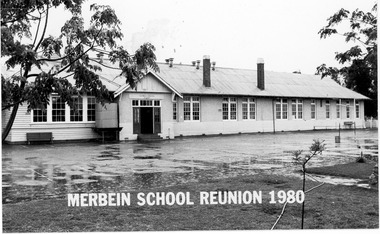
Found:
[2,56,368,143]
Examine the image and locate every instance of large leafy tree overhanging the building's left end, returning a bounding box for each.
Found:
[1,0,158,141]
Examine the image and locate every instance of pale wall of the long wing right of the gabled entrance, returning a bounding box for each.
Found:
[171,96,364,137]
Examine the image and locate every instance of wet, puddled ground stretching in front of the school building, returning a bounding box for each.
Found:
[2,130,378,203]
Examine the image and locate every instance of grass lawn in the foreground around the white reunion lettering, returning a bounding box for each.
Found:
[3,174,379,232]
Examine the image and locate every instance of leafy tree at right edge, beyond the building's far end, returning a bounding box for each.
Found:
[317,4,377,117]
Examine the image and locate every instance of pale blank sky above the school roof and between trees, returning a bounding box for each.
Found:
[43,0,376,74]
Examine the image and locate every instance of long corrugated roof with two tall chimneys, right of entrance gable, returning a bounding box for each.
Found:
[158,64,368,99]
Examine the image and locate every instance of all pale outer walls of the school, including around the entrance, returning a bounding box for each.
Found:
[2,88,365,142]
